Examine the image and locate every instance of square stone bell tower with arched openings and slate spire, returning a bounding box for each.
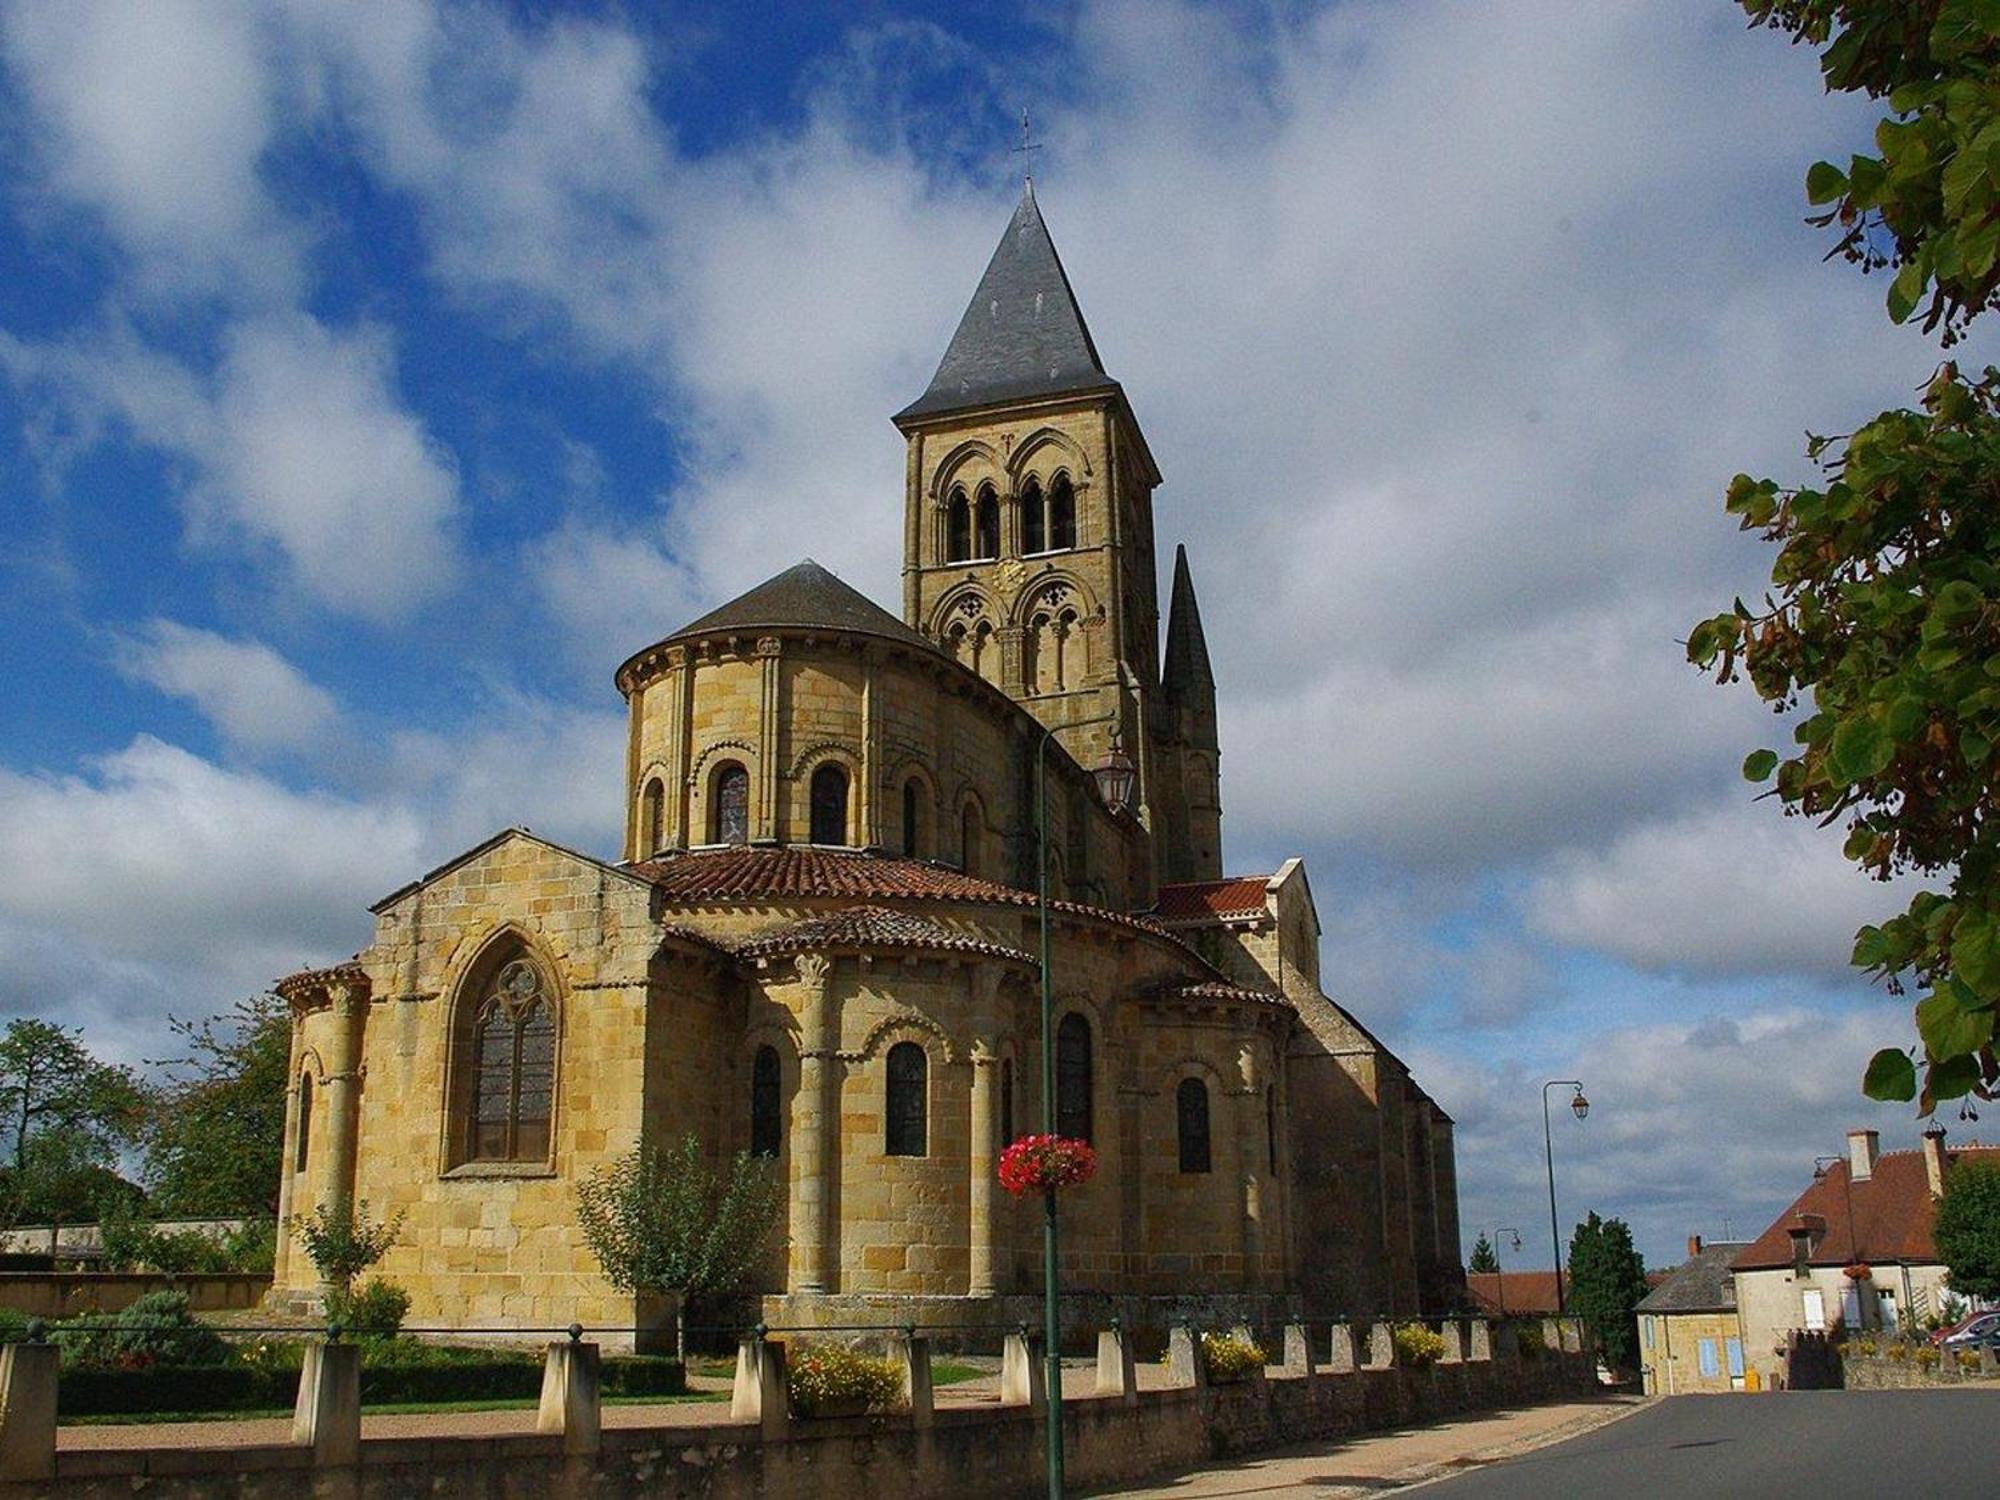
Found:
[896,182,1202,880]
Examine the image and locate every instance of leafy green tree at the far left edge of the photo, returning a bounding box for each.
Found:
[0,1016,146,1224]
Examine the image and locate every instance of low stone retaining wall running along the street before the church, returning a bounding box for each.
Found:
[0,1340,1594,1500]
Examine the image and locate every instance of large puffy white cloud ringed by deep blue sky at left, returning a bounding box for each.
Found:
[0,312,460,620]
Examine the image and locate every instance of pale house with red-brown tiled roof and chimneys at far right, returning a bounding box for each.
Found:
[1732,1126,2000,1374]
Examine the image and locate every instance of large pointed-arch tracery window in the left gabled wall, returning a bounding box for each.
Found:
[466,958,556,1162]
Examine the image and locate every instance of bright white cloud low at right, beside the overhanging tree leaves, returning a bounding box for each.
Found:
[1526,804,1920,980]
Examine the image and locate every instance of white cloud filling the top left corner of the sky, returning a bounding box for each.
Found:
[0,0,304,300]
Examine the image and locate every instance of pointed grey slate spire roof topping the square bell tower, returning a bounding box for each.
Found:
[896,182,1118,422]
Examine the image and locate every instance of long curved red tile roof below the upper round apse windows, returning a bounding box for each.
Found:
[620,844,1180,946]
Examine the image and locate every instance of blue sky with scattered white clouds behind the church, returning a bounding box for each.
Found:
[0,0,1970,1264]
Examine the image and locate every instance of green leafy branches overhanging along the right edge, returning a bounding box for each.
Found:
[1688,0,2000,1114]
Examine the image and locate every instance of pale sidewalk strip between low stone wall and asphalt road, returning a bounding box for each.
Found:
[1092,1396,1648,1500]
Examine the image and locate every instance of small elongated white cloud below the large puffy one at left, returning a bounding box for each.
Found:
[116,620,336,750]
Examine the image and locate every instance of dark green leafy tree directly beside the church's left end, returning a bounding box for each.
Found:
[146,994,292,1218]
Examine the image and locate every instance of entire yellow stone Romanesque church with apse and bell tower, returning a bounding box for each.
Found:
[274,188,1464,1328]
